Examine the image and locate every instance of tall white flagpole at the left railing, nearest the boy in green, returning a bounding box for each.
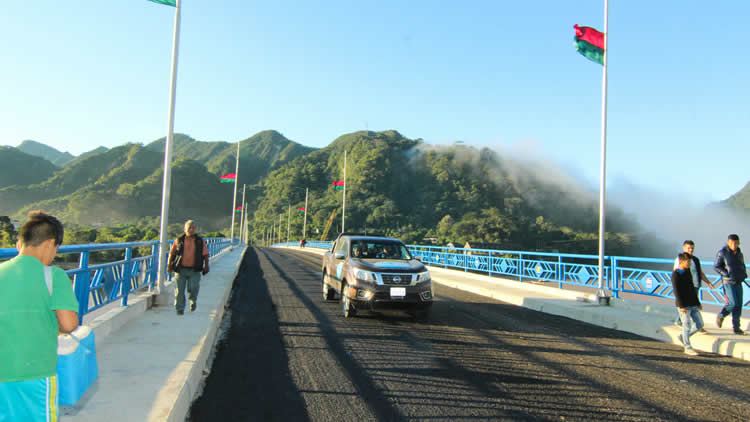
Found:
[156,0,181,294]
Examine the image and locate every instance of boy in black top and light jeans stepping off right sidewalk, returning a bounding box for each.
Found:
[672,253,703,356]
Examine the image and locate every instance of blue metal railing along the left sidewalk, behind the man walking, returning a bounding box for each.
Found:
[0,238,238,323]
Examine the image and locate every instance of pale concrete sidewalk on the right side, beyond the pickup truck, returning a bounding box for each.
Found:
[290,247,750,360]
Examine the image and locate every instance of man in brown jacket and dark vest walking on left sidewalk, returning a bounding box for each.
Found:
[167,220,208,315]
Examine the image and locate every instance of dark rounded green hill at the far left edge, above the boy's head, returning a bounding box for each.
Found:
[0,146,57,190]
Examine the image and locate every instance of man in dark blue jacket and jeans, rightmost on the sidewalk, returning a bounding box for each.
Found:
[714,234,747,335]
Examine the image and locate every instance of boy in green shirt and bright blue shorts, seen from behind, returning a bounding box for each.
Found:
[0,211,78,422]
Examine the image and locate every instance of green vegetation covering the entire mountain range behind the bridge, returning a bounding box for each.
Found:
[5,130,750,256]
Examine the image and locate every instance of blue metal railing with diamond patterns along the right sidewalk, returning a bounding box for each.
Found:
[272,242,750,309]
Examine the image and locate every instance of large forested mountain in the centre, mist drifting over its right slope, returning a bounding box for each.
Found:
[251,130,638,253]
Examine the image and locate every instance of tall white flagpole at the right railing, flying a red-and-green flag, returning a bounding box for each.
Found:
[597,0,609,297]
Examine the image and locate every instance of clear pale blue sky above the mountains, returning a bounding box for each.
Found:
[0,0,750,202]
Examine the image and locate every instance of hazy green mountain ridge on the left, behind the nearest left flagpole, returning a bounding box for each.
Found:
[0,131,313,230]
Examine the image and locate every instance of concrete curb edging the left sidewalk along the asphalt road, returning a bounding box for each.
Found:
[160,247,247,422]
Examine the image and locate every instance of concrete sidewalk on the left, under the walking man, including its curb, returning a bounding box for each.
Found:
[60,248,244,422]
